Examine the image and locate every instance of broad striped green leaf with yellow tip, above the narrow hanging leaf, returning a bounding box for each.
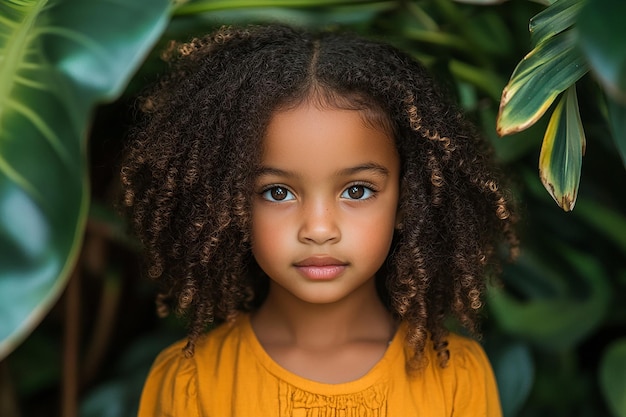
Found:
[497,30,588,136]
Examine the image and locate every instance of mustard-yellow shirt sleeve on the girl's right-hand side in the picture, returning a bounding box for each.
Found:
[450,338,502,417]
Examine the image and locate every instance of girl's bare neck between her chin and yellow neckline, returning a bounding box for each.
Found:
[252,280,395,348]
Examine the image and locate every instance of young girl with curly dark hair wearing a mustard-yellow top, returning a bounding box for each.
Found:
[122,26,516,417]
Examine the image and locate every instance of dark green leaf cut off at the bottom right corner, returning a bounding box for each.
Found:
[600,338,626,417]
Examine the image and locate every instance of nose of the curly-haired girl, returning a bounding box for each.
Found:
[298,197,341,245]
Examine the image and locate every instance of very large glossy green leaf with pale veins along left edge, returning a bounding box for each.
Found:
[0,0,170,359]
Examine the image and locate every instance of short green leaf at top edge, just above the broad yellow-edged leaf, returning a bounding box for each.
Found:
[528,0,585,47]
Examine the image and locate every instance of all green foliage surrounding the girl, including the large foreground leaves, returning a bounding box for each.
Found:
[0,0,626,417]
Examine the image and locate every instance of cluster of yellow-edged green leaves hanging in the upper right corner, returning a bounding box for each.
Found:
[497,0,626,211]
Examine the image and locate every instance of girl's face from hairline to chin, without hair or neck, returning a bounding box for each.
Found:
[252,103,400,303]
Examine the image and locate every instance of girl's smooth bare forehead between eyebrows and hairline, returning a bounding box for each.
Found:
[261,102,399,173]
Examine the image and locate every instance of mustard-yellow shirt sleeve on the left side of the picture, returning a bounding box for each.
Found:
[138,342,199,417]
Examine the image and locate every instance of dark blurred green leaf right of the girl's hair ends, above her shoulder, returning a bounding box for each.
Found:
[487,246,610,351]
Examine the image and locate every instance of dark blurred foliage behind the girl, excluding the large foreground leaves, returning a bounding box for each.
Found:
[0,0,626,417]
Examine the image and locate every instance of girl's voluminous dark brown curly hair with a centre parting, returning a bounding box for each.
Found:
[121,25,517,369]
